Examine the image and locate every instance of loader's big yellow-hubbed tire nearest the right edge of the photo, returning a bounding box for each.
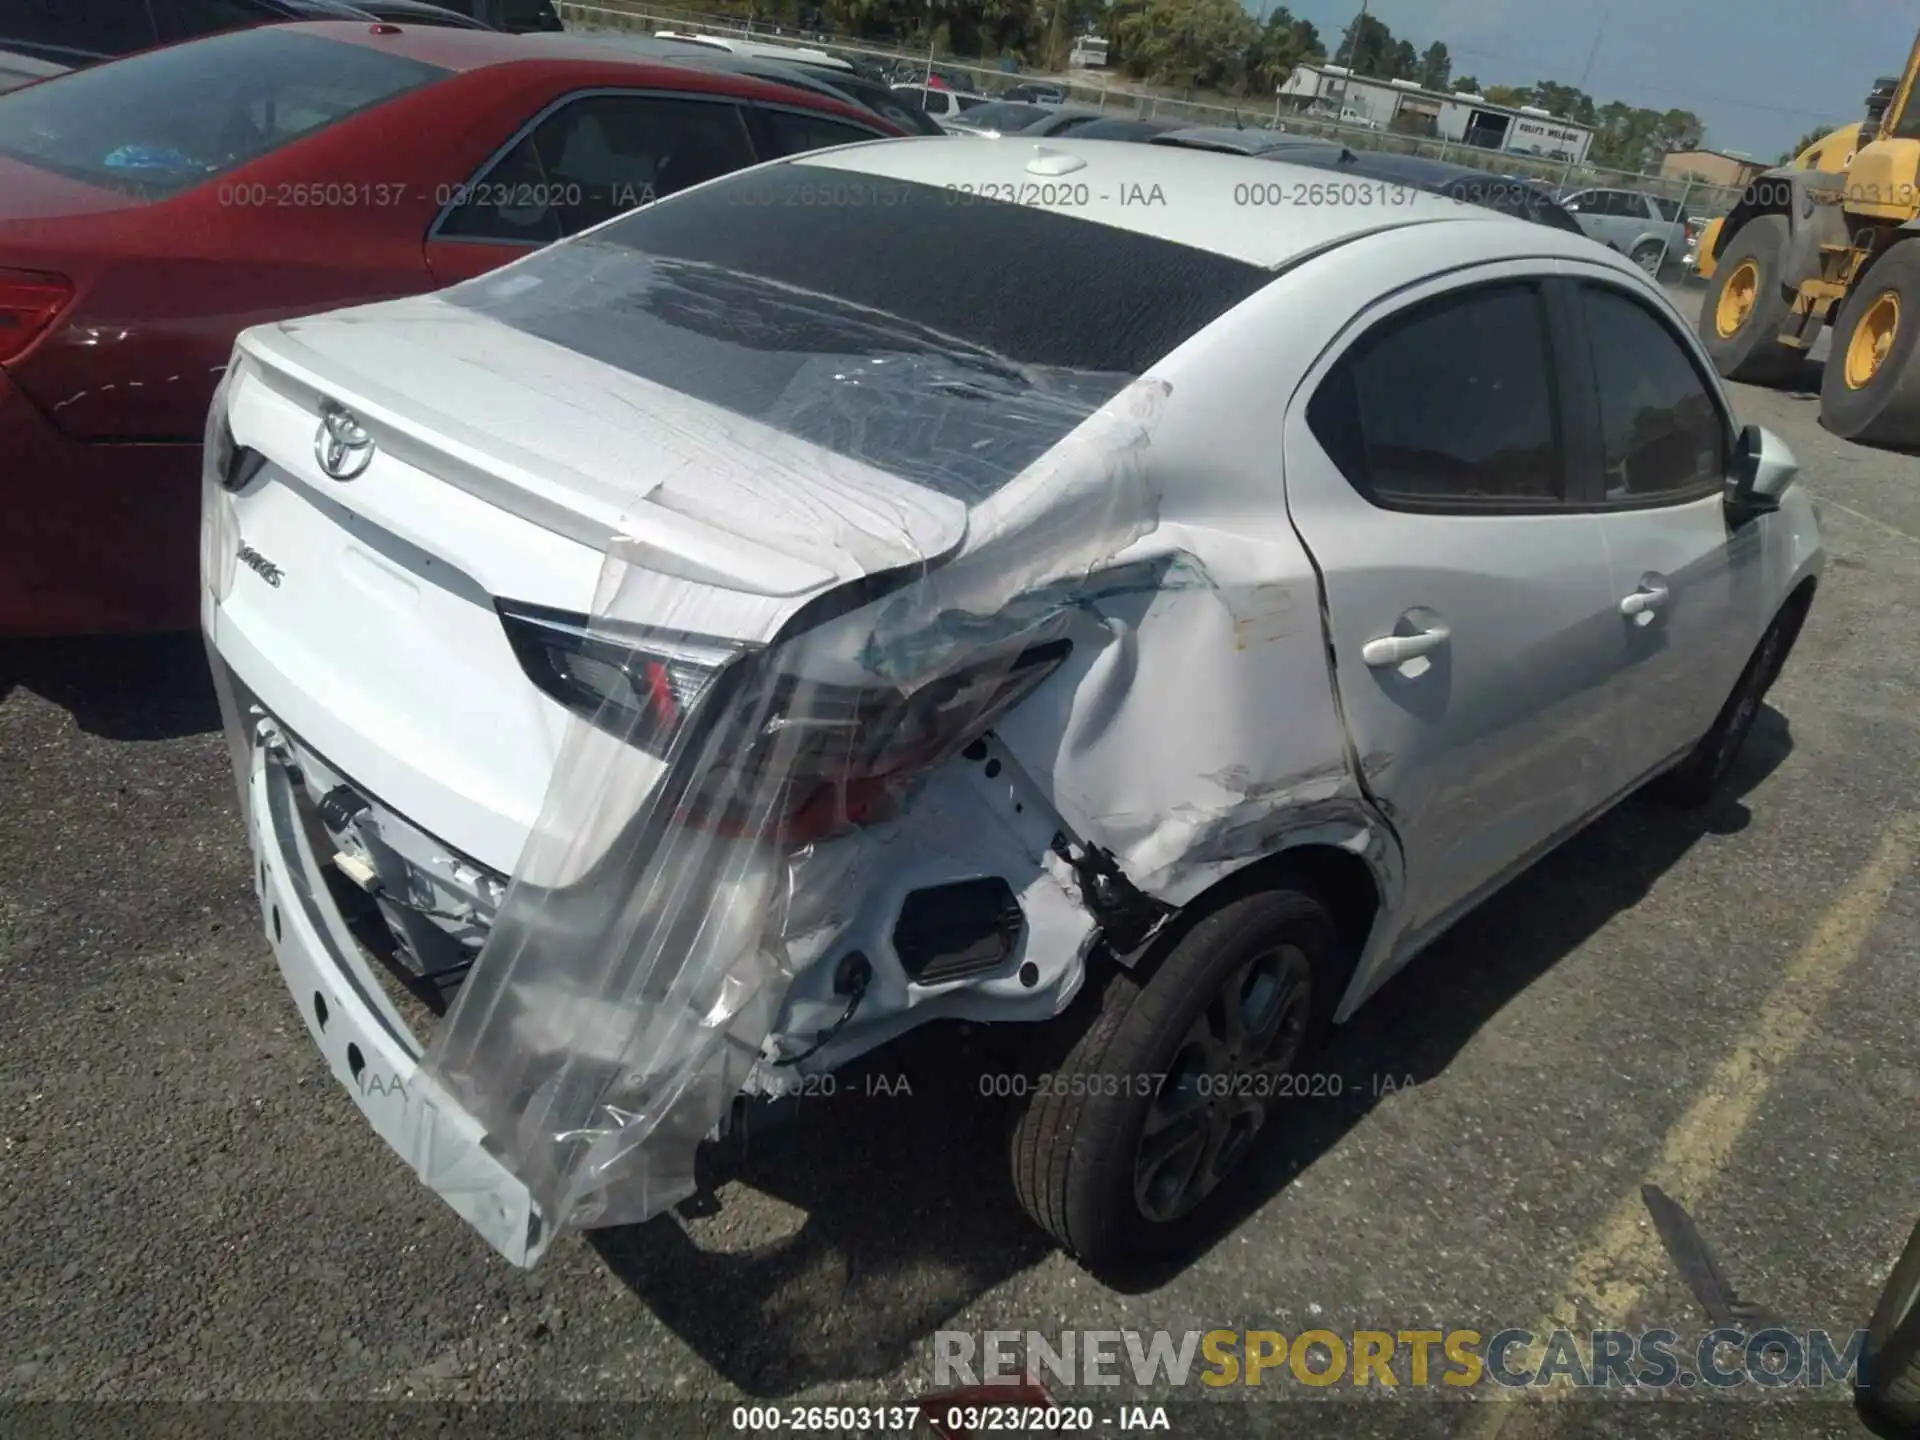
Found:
[1820,240,1920,445]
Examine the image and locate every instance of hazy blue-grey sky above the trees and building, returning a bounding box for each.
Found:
[1267,0,1920,163]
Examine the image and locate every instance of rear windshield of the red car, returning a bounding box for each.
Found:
[0,29,447,200]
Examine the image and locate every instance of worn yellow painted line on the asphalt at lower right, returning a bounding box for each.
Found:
[1465,814,1920,1440]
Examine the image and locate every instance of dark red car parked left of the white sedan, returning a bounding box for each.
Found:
[0,23,899,636]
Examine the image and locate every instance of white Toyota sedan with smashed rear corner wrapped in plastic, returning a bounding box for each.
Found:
[202,140,1824,1263]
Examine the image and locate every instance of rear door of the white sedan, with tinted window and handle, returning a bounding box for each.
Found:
[1286,265,1619,933]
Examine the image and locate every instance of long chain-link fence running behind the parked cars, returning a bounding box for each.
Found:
[557,0,1741,257]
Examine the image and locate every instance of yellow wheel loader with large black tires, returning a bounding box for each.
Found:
[1699,50,1920,445]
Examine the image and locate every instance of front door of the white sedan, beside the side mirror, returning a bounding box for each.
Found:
[1565,267,1772,787]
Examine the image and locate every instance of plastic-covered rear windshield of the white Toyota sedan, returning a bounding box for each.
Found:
[442,163,1273,501]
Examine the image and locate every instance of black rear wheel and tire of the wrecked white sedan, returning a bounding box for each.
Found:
[1012,889,1348,1269]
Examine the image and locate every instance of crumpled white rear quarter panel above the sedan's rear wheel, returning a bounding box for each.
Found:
[998,275,1398,904]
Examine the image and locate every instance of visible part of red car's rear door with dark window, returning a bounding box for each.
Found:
[426,90,758,284]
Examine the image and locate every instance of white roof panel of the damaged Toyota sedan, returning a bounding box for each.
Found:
[780,134,1543,269]
